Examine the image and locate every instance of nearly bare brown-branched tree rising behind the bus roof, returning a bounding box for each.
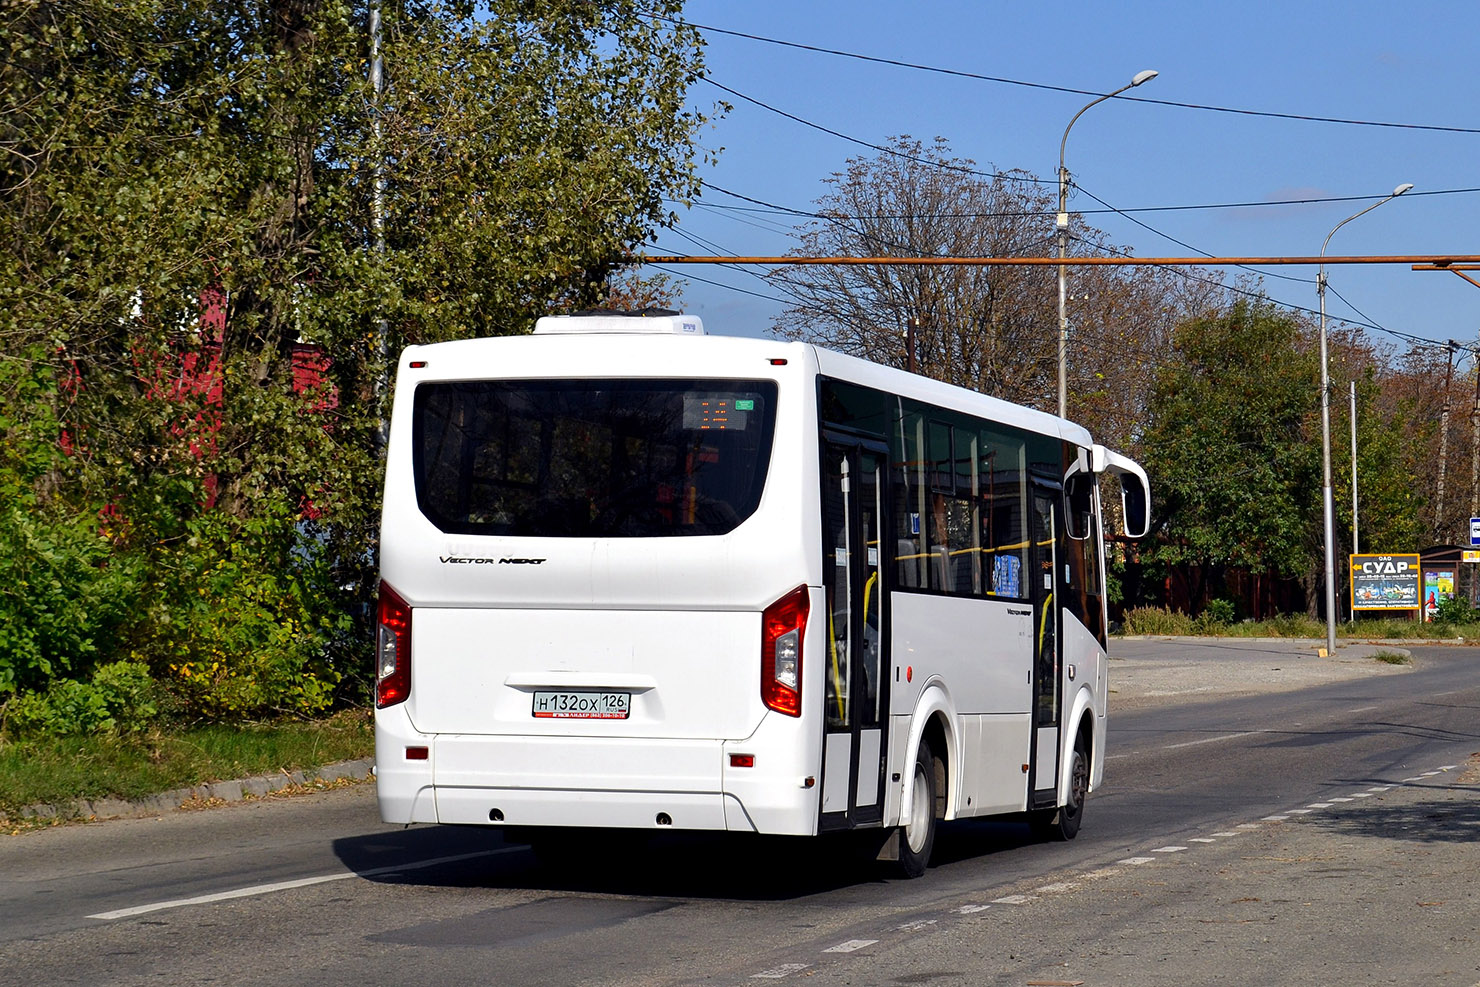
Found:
[770,138,1222,450]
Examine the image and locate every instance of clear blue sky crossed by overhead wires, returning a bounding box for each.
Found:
[650,0,1480,355]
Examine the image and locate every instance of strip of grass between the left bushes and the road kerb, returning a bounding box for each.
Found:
[0,712,374,817]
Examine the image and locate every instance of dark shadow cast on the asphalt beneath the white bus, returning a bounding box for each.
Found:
[334,820,1035,901]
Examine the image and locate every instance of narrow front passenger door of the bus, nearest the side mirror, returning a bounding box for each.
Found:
[1029,481,1061,808]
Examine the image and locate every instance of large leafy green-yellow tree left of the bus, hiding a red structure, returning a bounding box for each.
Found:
[0,0,716,722]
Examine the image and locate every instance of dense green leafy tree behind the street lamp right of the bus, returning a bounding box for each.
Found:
[1143,300,1421,616]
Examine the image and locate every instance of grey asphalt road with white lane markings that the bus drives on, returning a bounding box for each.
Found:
[0,642,1480,987]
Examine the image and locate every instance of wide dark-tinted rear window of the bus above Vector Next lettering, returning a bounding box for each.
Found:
[413,380,776,537]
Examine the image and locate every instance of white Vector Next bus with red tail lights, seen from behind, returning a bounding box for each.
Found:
[376,315,1148,876]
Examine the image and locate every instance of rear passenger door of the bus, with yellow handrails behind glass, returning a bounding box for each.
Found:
[820,439,888,829]
